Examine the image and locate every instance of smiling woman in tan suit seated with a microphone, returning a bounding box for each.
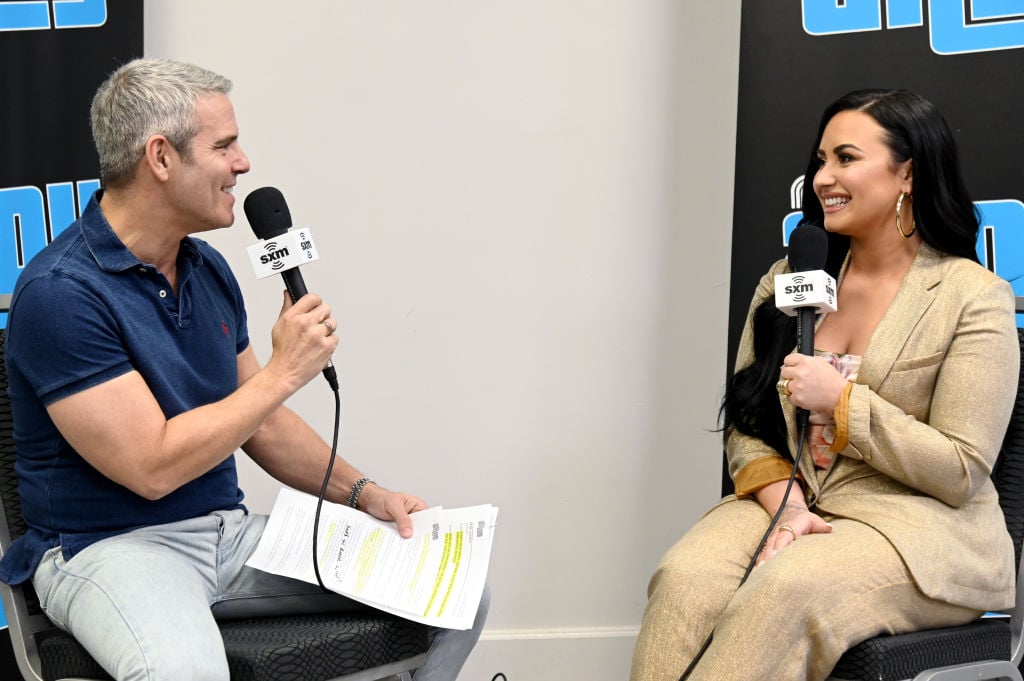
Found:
[631,90,1020,681]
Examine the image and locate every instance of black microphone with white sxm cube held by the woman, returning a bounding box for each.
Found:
[775,222,837,426]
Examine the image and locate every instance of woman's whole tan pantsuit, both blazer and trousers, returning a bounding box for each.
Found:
[632,244,1020,681]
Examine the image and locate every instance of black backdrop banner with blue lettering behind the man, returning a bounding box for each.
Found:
[0,0,142,667]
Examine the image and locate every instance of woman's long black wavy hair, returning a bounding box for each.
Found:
[719,89,980,459]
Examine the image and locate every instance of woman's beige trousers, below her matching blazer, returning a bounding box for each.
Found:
[630,493,981,681]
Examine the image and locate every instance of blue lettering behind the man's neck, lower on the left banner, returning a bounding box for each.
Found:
[0,179,99,327]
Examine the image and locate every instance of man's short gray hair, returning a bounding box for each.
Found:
[90,59,231,185]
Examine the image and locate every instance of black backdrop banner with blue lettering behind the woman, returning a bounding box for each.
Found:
[723,0,1024,492]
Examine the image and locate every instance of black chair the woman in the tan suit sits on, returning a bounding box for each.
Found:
[828,298,1024,681]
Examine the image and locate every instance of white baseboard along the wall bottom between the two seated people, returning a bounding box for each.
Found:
[459,628,638,681]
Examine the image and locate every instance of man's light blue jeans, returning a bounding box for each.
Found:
[33,510,489,681]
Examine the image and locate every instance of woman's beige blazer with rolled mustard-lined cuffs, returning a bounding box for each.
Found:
[726,240,1020,610]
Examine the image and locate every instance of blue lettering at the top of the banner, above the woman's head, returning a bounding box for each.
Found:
[802,0,1024,54]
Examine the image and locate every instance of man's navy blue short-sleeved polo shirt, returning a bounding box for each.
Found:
[0,191,249,584]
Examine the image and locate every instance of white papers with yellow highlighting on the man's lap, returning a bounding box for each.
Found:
[246,487,498,629]
